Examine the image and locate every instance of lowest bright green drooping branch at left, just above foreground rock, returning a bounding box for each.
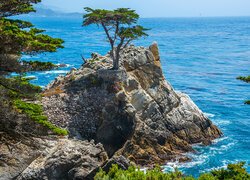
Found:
[14,99,68,135]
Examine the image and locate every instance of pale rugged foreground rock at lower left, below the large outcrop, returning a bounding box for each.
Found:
[16,139,108,180]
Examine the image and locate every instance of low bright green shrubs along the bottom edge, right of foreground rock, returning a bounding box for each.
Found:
[94,162,250,180]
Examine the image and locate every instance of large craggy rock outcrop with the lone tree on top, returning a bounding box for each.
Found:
[43,44,222,165]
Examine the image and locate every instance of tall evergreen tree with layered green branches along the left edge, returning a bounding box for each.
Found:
[0,0,63,135]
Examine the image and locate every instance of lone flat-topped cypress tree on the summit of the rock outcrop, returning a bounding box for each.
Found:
[83,7,147,70]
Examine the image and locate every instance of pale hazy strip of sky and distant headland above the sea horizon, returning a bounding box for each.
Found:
[43,0,250,17]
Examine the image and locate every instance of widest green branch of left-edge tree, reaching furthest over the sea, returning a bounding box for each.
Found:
[0,18,63,55]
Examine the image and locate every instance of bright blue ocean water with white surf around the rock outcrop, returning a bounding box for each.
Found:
[21,17,250,176]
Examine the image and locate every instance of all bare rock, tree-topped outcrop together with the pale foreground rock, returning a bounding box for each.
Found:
[0,44,222,179]
